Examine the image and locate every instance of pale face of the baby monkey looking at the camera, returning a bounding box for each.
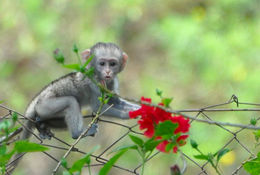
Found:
[96,57,120,82]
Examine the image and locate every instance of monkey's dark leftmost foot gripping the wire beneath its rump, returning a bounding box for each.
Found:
[35,117,54,140]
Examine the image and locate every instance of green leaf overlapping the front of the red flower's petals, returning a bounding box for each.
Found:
[155,120,178,138]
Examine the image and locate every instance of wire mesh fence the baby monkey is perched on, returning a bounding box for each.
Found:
[0,95,260,175]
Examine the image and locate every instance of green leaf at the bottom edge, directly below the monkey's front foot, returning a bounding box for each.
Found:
[69,145,100,173]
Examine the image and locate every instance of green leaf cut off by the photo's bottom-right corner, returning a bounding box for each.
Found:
[243,152,260,175]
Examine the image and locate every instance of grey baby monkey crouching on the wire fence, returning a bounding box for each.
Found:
[21,42,139,139]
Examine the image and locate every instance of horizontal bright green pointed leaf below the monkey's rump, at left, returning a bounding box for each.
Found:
[14,140,49,153]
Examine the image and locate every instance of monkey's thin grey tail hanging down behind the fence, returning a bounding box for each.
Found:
[6,110,34,174]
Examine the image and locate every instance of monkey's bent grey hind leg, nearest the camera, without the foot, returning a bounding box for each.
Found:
[35,96,87,139]
